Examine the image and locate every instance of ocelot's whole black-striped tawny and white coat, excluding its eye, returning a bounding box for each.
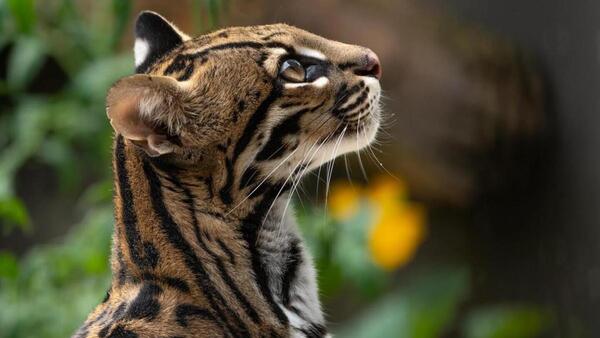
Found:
[74,12,380,338]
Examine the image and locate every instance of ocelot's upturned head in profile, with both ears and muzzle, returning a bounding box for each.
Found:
[107,12,381,211]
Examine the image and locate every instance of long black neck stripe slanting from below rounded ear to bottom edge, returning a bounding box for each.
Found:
[142,160,250,337]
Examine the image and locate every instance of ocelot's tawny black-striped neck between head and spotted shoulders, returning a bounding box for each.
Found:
[113,136,288,332]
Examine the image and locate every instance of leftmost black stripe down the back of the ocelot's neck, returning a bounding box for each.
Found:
[115,135,158,270]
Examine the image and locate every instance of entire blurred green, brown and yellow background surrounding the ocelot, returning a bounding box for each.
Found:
[0,0,600,338]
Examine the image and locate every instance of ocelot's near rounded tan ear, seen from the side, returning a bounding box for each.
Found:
[106,74,186,156]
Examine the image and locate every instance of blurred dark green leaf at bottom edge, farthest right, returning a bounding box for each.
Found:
[464,305,550,338]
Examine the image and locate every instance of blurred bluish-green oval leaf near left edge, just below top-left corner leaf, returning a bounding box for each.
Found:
[6,36,46,90]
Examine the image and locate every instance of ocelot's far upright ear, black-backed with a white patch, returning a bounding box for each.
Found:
[133,11,190,73]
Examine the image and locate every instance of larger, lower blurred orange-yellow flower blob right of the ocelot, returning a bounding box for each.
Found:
[369,205,425,270]
